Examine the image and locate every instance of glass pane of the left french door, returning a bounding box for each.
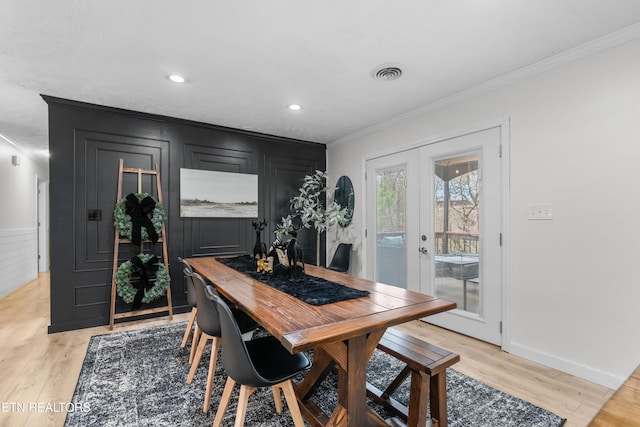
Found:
[376,166,407,288]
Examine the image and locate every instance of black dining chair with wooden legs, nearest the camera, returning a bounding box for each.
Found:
[205,286,311,427]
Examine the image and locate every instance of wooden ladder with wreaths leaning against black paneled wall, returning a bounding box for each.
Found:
[109,159,173,329]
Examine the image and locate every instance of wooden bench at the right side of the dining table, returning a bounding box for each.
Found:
[367,328,460,427]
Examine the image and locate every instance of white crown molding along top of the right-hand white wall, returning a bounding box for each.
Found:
[327,23,640,147]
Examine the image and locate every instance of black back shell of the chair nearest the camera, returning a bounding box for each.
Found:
[208,292,271,387]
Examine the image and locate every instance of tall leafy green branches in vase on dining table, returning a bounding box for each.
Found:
[275,170,347,265]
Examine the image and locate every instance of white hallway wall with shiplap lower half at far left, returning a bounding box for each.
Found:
[0,138,48,298]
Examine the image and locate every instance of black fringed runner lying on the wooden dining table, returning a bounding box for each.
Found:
[216,255,369,305]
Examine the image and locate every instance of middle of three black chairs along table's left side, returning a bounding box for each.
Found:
[184,269,258,412]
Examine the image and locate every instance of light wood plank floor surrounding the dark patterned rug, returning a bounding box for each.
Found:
[0,274,613,427]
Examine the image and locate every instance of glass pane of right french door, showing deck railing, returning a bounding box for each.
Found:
[433,153,480,313]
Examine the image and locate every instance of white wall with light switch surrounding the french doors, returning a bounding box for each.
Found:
[327,40,640,388]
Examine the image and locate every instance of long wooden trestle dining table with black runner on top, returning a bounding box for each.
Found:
[187,257,456,427]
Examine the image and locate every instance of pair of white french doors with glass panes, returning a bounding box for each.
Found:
[366,127,503,345]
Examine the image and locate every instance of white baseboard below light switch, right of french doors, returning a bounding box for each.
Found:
[508,342,626,390]
